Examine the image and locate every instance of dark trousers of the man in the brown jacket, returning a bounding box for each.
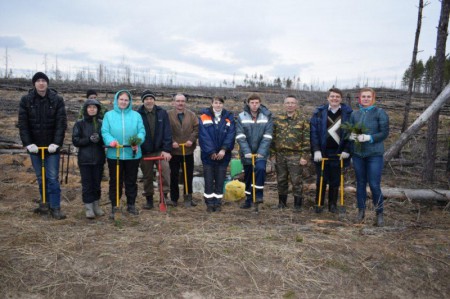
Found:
[169,155,194,201]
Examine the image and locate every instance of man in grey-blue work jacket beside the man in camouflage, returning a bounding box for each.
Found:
[236,94,273,209]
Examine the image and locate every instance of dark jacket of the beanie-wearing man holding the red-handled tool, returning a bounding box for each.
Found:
[138,105,172,155]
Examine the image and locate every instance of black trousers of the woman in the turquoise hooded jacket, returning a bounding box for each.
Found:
[107,159,140,207]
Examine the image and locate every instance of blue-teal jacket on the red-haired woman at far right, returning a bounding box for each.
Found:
[350,106,389,158]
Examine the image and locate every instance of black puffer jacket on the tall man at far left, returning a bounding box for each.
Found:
[18,89,67,154]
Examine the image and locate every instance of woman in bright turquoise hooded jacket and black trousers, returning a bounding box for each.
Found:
[102,90,145,218]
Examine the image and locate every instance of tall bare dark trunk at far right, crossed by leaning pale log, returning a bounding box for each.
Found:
[422,0,450,182]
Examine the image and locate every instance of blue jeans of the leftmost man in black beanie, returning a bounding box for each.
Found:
[30,153,61,209]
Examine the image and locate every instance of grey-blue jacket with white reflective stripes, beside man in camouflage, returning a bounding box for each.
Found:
[236,105,273,165]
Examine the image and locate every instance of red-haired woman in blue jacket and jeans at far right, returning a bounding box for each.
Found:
[350,88,389,226]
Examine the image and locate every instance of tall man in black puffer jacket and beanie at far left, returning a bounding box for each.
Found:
[19,72,67,220]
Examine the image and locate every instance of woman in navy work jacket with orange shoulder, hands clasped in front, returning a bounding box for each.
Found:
[198,97,236,212]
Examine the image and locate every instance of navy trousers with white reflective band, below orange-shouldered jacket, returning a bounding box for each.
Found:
[203,164,227,206]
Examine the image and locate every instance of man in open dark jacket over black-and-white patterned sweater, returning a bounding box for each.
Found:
[310,88,352,213]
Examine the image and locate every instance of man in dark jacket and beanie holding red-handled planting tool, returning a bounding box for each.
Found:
[138,90,172,210]
